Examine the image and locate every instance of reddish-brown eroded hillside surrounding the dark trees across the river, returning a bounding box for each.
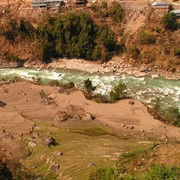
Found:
[0,0,180,72]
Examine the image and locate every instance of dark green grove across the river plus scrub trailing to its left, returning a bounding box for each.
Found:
[3,13,118,63]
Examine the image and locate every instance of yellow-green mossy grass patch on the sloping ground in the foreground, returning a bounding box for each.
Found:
[23,121,151,179]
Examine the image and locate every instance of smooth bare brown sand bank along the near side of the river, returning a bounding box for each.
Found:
[0,82,180,159]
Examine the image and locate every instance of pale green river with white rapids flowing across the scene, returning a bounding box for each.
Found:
[0,68,180,110]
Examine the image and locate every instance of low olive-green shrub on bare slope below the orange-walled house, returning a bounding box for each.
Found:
[138,31,156,44]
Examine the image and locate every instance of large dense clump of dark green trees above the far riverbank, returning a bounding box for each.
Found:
[36,14,116,63]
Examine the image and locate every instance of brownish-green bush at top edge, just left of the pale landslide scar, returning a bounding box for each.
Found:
[108,2,125,22]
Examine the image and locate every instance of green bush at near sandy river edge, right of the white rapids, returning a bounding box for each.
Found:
[109,83,126,103]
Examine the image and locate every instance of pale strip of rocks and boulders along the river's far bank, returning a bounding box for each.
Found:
[0,57,180,80]
